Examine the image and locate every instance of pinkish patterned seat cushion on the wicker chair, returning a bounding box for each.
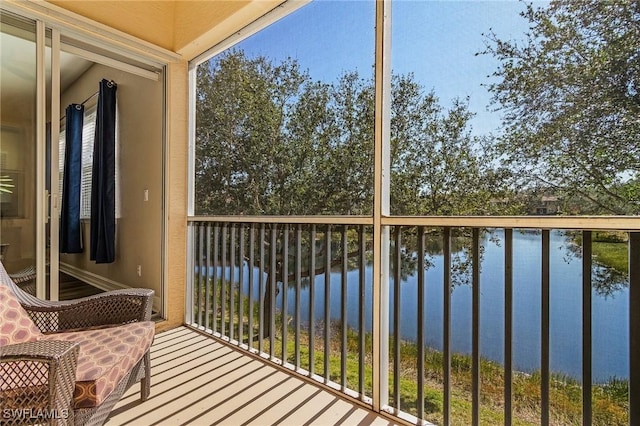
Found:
[40,321,155,408]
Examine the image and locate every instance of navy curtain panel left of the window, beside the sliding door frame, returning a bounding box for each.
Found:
[60,104,84,253]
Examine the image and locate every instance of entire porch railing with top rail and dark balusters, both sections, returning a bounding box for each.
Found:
[187,217,640,425]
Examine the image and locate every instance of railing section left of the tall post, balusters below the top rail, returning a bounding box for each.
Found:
[190,222,371,400]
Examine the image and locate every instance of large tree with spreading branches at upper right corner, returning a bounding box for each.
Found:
[484,0,640,214]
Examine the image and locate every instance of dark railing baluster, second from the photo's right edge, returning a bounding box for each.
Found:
[582,231,592,426]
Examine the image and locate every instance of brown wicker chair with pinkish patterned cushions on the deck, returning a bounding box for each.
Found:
[0,263,155,425]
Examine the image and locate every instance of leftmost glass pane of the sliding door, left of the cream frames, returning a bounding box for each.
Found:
[0,12,46,292]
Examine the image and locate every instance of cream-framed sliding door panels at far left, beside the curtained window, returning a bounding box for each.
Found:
[0,11,85,300]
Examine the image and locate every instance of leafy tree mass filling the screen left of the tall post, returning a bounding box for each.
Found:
[195,51,373,215]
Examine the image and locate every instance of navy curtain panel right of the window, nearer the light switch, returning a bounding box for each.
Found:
[90,80,118,263]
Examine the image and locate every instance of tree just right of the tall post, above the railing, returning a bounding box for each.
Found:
[391,74,519,215]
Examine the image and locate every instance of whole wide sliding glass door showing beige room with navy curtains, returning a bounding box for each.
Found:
[0,3,166,315]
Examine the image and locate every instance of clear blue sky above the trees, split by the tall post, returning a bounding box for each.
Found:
[232,0,544,134]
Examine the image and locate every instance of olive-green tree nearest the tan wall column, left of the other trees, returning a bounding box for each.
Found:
[195,52,308,214]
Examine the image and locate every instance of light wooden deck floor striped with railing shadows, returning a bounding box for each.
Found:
[106,327,394,426]
